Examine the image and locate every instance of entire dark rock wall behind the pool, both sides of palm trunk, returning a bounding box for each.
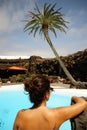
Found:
[0,49,87,82]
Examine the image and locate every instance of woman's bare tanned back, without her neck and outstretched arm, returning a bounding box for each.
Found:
[14,107,56,130]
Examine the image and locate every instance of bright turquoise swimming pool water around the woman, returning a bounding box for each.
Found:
[0,87,71,130]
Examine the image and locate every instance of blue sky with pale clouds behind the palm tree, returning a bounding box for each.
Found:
[0,0,87,58]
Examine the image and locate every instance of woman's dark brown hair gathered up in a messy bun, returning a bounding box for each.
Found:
[24,75,53,106]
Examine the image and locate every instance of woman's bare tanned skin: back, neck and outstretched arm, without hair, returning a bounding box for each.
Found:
[13,93,87,130]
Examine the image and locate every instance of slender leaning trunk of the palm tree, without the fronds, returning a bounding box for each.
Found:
[43,29,78,86]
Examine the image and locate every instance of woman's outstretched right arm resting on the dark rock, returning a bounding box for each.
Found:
[55,96,87,124]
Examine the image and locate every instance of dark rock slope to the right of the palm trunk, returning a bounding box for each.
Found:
[62,49,87,82]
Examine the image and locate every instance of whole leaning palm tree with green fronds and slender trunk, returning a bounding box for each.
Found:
[24,3,78,85]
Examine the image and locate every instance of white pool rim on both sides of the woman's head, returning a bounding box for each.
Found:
[0,84,87,97]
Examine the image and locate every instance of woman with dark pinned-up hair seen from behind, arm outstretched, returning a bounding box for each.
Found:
[13,75,87,130]
